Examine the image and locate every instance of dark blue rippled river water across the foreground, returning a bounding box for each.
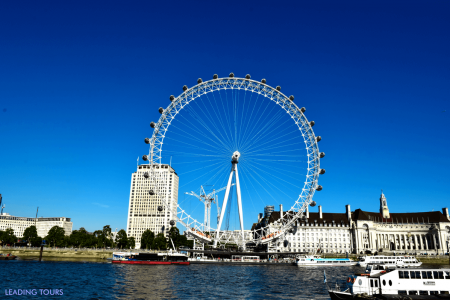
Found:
[0,259,446,299]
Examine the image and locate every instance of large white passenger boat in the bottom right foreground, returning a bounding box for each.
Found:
[328,267,450,300]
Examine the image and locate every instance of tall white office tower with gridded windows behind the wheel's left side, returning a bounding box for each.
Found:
[127,165,178,249]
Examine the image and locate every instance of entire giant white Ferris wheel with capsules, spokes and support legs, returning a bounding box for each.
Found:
[143,73,325,248]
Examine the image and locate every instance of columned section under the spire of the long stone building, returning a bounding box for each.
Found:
[352,193,450,255]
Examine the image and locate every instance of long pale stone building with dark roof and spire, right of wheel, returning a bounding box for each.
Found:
[252,193,450,254]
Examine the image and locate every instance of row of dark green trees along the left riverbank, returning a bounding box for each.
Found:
[0,225,193,250]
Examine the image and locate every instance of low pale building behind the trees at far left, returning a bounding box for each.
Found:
[0,213,73,238]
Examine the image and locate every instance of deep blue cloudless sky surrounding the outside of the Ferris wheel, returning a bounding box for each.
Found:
[0,1,450,231]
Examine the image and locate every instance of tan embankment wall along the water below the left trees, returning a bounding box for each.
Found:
[0,248,113,259]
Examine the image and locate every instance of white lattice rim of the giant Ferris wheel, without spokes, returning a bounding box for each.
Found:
[149,77,321,243]
